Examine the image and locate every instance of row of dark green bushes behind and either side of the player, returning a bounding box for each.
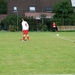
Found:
[1,15,51,31]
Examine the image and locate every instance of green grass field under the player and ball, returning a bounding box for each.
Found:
[0,31,75,75]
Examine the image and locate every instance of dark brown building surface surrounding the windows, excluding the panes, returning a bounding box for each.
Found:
[7,0,61,16]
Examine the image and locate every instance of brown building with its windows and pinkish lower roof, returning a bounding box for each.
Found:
[7,0,61,17]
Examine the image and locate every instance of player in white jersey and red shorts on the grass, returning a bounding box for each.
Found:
[22,18,30,41]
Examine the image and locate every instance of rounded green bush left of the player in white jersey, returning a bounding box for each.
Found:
[1,15,22,31]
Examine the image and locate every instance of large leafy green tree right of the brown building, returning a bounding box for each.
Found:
[53,0,74,25]
